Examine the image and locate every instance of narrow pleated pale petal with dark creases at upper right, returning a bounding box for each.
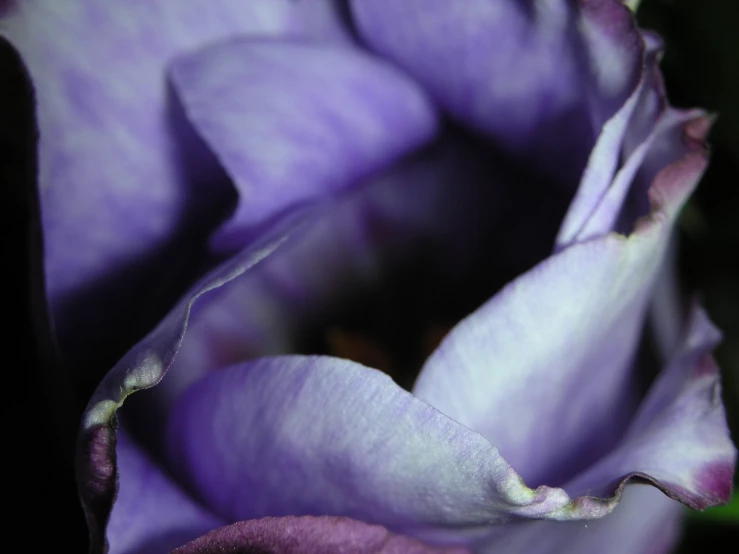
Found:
[556,34,711,245]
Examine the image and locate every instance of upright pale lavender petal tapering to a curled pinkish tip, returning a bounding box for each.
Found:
[414,113,707,484]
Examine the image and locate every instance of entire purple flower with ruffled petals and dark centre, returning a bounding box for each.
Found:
[2,0,736,554]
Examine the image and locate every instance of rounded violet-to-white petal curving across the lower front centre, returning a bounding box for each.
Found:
[167,356,580,534]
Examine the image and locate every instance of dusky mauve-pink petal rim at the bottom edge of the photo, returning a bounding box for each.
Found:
[173,516,468,554]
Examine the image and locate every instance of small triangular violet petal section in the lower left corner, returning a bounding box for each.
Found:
[107,430,227,554]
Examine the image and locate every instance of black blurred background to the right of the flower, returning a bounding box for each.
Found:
[637,0,739,554]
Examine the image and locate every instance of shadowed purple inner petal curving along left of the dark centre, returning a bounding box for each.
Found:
[134,135,552,432]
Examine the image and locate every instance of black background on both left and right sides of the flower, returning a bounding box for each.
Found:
[0,0,739,553]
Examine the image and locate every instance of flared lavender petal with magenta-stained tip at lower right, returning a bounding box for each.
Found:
[565,306,737,510]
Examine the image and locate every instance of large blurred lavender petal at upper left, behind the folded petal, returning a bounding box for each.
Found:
[0,0,346,380]
